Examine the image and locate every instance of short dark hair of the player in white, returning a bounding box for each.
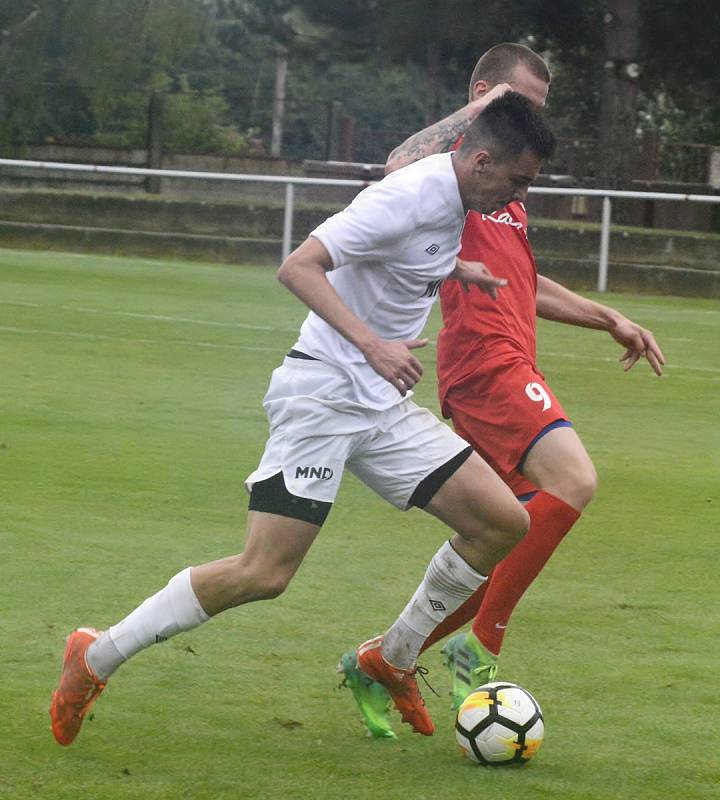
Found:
[458,92,556,161]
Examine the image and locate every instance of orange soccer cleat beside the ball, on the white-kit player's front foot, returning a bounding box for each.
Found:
[357,636,435,736]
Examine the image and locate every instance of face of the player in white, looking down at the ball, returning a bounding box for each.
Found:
[461,149,540,214]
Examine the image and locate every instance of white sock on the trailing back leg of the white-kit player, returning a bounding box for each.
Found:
[86,567,210,680]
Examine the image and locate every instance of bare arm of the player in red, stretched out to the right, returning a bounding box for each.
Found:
[537,275,665,375]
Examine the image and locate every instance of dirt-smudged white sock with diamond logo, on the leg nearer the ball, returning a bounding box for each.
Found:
[382,542,487,669]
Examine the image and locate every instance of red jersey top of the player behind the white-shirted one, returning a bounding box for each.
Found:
[437,202,537,412]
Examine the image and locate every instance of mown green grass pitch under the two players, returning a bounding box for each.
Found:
[0,250,720,800]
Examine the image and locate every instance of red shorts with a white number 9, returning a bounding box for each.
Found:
[442,357,567,495]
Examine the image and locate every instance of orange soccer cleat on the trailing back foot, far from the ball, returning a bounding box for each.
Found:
[50,628,105,746]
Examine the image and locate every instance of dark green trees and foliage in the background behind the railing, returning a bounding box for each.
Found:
[0,0,720,164]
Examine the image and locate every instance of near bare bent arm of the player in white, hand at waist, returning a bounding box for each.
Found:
[278,236,428,396]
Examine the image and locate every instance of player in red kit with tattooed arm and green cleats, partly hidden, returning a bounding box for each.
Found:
[339,43,665,737]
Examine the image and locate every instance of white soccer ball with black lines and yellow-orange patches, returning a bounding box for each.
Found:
[455,681,545,767]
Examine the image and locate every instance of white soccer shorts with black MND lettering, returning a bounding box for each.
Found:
[245,358,468,509]
